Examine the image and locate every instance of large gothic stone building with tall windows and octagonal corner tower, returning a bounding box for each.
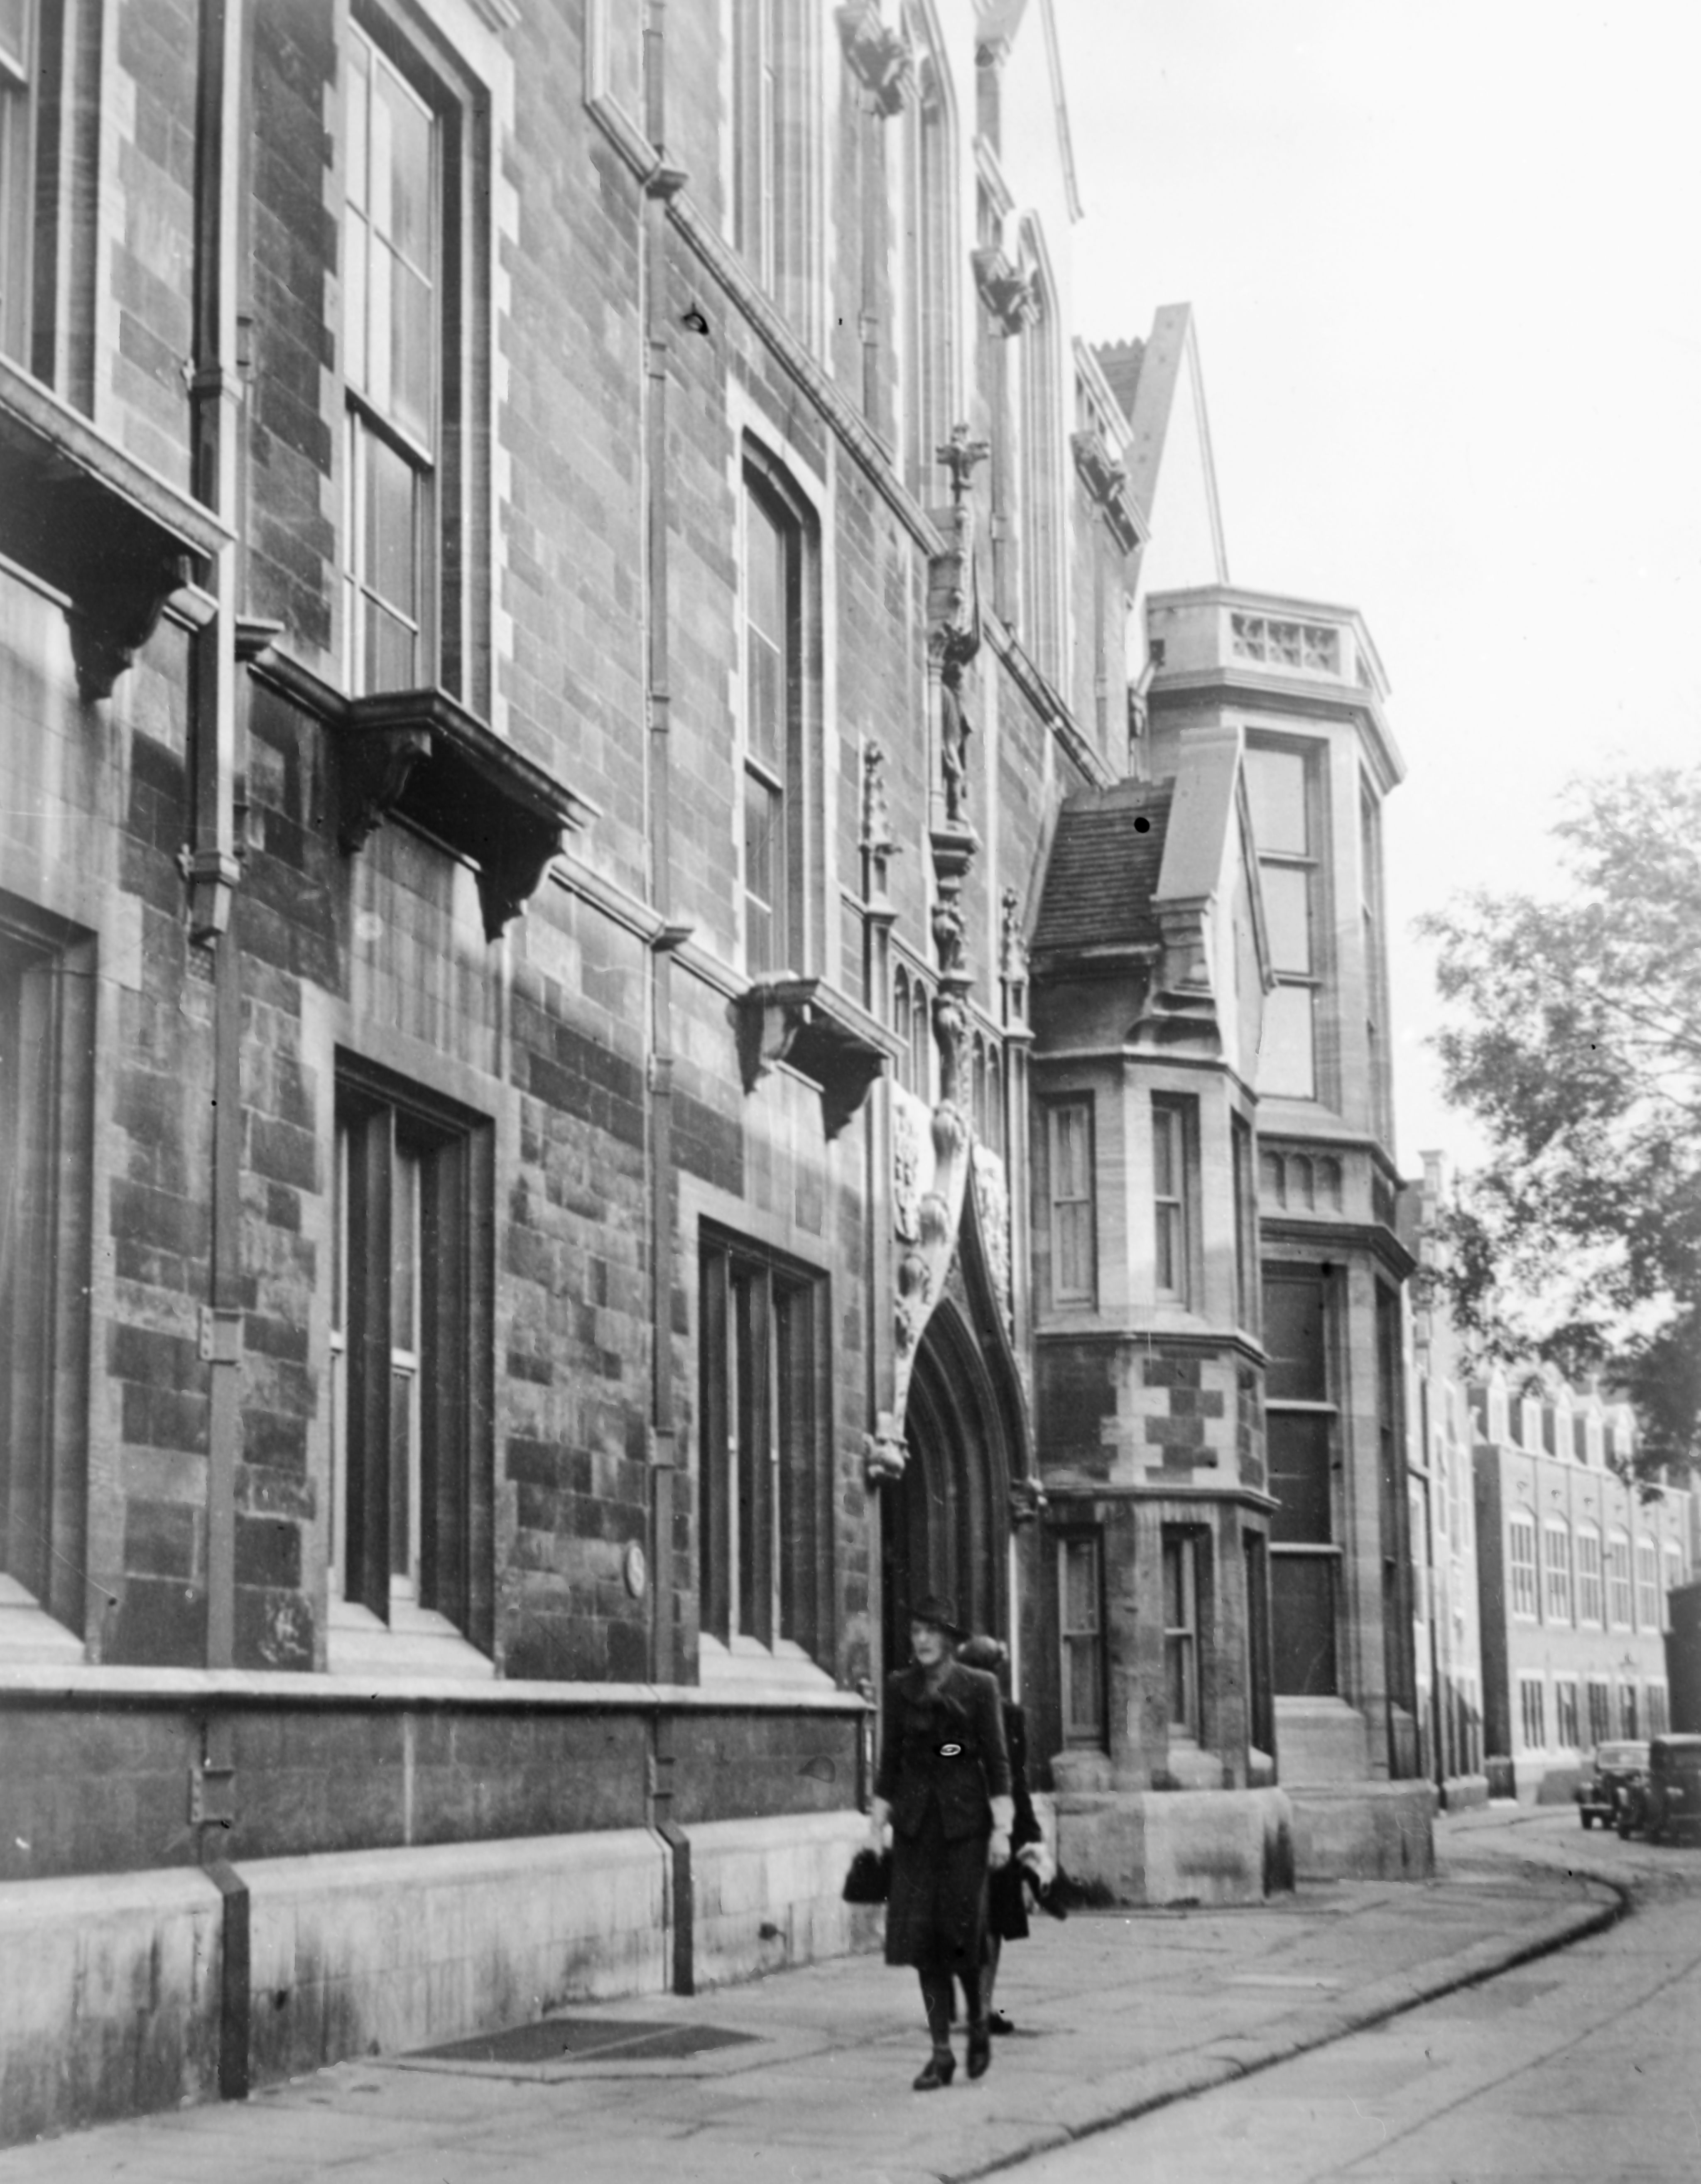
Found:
[0,0,1406,2136]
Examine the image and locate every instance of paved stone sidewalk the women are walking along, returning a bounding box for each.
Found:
[0,1824,1620,2184]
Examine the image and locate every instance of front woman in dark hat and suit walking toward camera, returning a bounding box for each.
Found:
[873,1594,1013,2092]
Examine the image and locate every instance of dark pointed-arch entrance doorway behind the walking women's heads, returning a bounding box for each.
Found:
[880,1297,1011,1669]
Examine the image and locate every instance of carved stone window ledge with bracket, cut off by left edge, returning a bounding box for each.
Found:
[0,358,229,703]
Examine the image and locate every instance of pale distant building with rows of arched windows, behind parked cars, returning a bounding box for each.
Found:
[1470,1371,1692,1804]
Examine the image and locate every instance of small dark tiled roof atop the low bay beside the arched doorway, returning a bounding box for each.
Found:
[1031,782,1175,955]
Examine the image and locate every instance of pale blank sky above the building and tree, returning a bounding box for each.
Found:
[1057,0,1701,1175]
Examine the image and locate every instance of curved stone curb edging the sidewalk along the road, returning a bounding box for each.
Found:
[939,1861,1631,2184]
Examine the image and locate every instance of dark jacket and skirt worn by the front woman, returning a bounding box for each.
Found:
[873,1662,1011,1972]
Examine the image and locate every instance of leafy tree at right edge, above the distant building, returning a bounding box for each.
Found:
[1419,766,1701,1474]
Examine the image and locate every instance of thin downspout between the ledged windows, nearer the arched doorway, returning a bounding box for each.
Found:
[642,0,696,1994]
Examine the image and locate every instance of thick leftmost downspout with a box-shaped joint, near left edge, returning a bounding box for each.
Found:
[186,0,249,2099]
